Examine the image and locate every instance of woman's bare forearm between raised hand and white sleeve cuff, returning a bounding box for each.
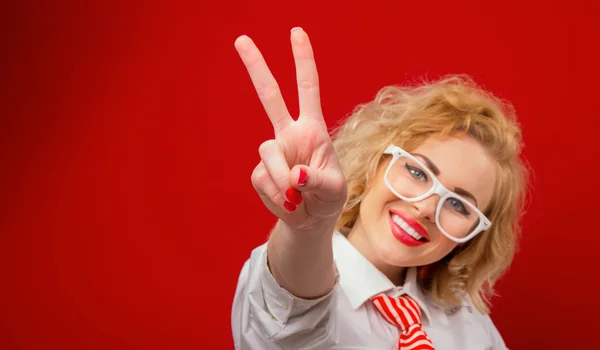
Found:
[267,220,335,299]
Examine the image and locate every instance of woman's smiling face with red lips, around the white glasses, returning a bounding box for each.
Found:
[348,136,496,270]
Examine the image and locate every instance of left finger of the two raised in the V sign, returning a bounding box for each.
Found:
[235,35,294,134]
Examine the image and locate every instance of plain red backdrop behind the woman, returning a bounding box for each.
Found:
[0,1,600,349]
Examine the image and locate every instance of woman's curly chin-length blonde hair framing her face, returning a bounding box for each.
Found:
[332,75,528,313]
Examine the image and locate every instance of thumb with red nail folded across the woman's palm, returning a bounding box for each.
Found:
[290,165,346,203]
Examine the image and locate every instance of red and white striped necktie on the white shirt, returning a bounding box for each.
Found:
[371,293,434,350]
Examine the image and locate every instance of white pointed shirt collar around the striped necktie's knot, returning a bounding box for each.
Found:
[333,231,431,326]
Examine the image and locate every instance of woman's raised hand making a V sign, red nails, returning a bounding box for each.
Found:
[235,28,346,230]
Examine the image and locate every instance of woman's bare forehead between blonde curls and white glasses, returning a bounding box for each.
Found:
[411,136,496,208]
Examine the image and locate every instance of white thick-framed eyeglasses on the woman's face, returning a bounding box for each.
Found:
[383,145,492,243]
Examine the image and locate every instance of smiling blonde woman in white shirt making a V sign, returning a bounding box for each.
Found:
[232,28,526,350]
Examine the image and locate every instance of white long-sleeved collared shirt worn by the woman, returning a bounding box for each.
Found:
[231,232,506,350]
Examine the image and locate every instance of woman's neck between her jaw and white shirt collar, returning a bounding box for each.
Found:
[347,220,406,286]
